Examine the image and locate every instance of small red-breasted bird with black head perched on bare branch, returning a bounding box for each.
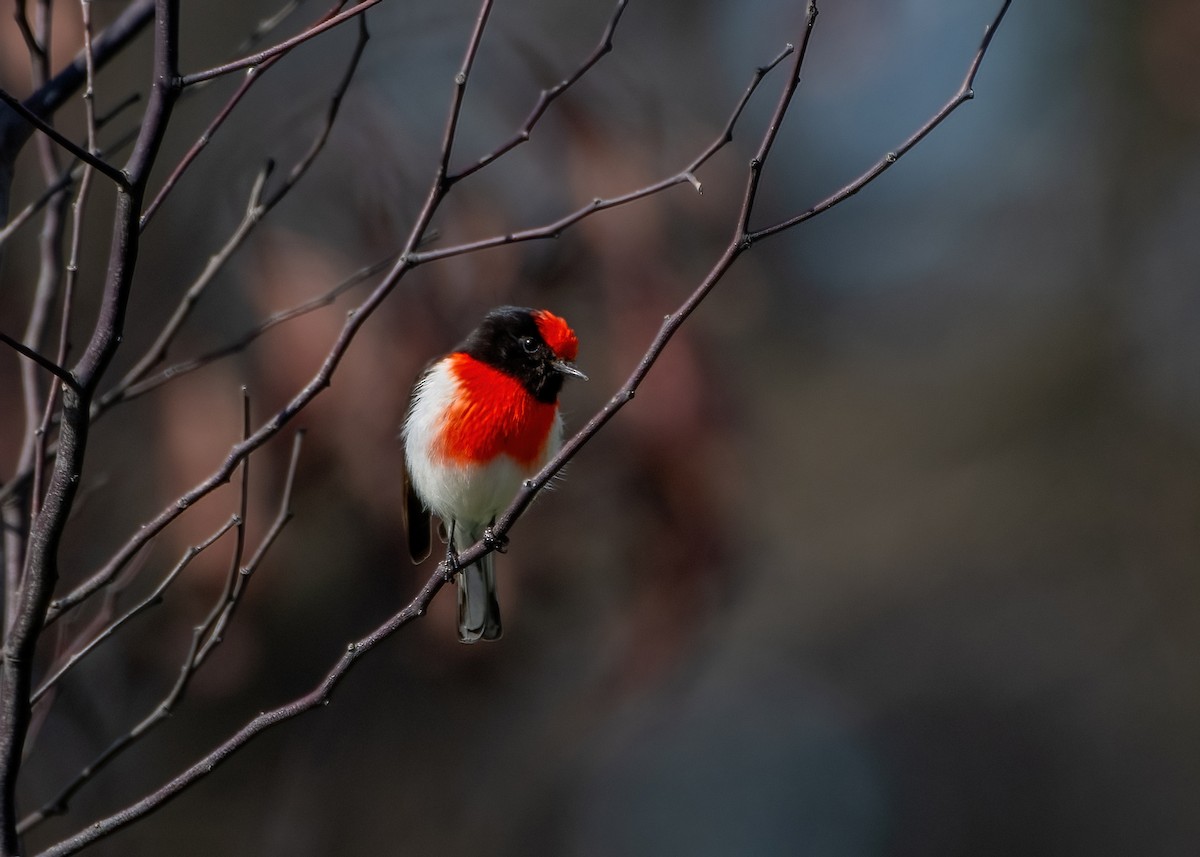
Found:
[401,306,587,643]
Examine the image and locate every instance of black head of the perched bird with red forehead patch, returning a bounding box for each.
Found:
[456,306,587,403]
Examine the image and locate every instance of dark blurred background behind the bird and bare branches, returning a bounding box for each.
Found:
[0,0,1200,857]
